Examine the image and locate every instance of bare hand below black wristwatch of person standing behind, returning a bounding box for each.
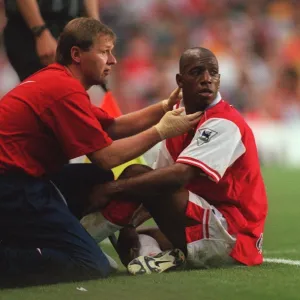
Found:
[35,29,57,66]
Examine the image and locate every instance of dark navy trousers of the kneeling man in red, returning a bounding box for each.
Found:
[0,164,113,279]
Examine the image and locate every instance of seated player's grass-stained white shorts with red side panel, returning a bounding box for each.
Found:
[185,192,236,268]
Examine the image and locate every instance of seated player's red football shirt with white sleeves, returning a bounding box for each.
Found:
[155,95,267,265]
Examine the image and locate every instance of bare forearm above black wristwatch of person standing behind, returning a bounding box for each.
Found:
[16,0,45,28]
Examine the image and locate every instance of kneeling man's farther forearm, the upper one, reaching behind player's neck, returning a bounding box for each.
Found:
[108,103,165,139]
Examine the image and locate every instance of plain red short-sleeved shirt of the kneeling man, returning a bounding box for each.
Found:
[0,64,113,176]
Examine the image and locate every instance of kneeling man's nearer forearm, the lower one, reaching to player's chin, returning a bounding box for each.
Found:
[88,127,161,169]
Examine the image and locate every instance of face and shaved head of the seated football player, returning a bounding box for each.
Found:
[176,50,220,113]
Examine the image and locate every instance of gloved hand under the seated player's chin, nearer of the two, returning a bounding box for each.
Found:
[154,107,202,140]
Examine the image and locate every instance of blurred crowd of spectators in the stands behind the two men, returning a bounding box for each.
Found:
[0,0,300,122]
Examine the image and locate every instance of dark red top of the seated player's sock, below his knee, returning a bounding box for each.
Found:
[101,199,140,226]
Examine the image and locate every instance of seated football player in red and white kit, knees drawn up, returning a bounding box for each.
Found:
[82,47,267,274]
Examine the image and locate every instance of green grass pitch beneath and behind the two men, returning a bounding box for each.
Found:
[0,167,300,300]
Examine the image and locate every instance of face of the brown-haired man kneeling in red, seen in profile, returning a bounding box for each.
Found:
[80,35,117,87]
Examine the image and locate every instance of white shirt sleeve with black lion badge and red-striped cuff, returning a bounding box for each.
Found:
[176,118,246,182]
